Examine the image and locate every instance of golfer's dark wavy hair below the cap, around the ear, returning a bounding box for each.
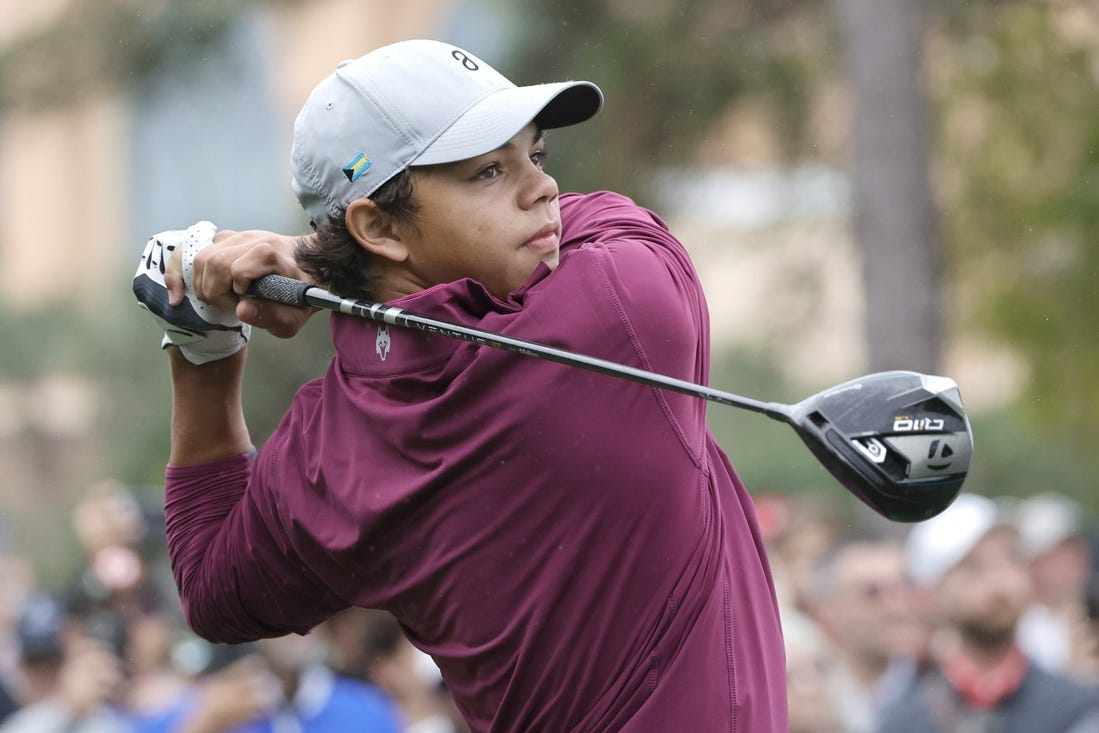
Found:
[295,168,420,300]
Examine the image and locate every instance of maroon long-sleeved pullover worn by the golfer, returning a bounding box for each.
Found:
[166,192,787,733]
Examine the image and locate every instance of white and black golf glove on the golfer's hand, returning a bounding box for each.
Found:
[134,221,252,364]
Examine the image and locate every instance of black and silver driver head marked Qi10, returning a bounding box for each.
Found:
[789,371,973,522]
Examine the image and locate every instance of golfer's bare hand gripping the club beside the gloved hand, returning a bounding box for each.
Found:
[164,230,315,338]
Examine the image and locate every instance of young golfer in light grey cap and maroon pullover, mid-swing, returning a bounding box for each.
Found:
[134,41,787,733]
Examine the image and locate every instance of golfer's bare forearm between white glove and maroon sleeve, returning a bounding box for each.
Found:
[168,346,252,466]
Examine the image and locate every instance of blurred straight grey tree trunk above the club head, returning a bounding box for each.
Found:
[836,0,943,374]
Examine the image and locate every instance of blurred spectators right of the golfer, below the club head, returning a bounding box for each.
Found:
[757,493,1099,733]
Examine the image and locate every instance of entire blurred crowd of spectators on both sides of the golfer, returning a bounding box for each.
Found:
[0,482,1099,733]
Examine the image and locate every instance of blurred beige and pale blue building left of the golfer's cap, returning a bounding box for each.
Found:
[0,0,454,308]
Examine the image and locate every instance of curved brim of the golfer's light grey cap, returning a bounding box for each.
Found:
[412,81,603,166]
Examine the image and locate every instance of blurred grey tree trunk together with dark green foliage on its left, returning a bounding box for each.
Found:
[505,0,942,371]
